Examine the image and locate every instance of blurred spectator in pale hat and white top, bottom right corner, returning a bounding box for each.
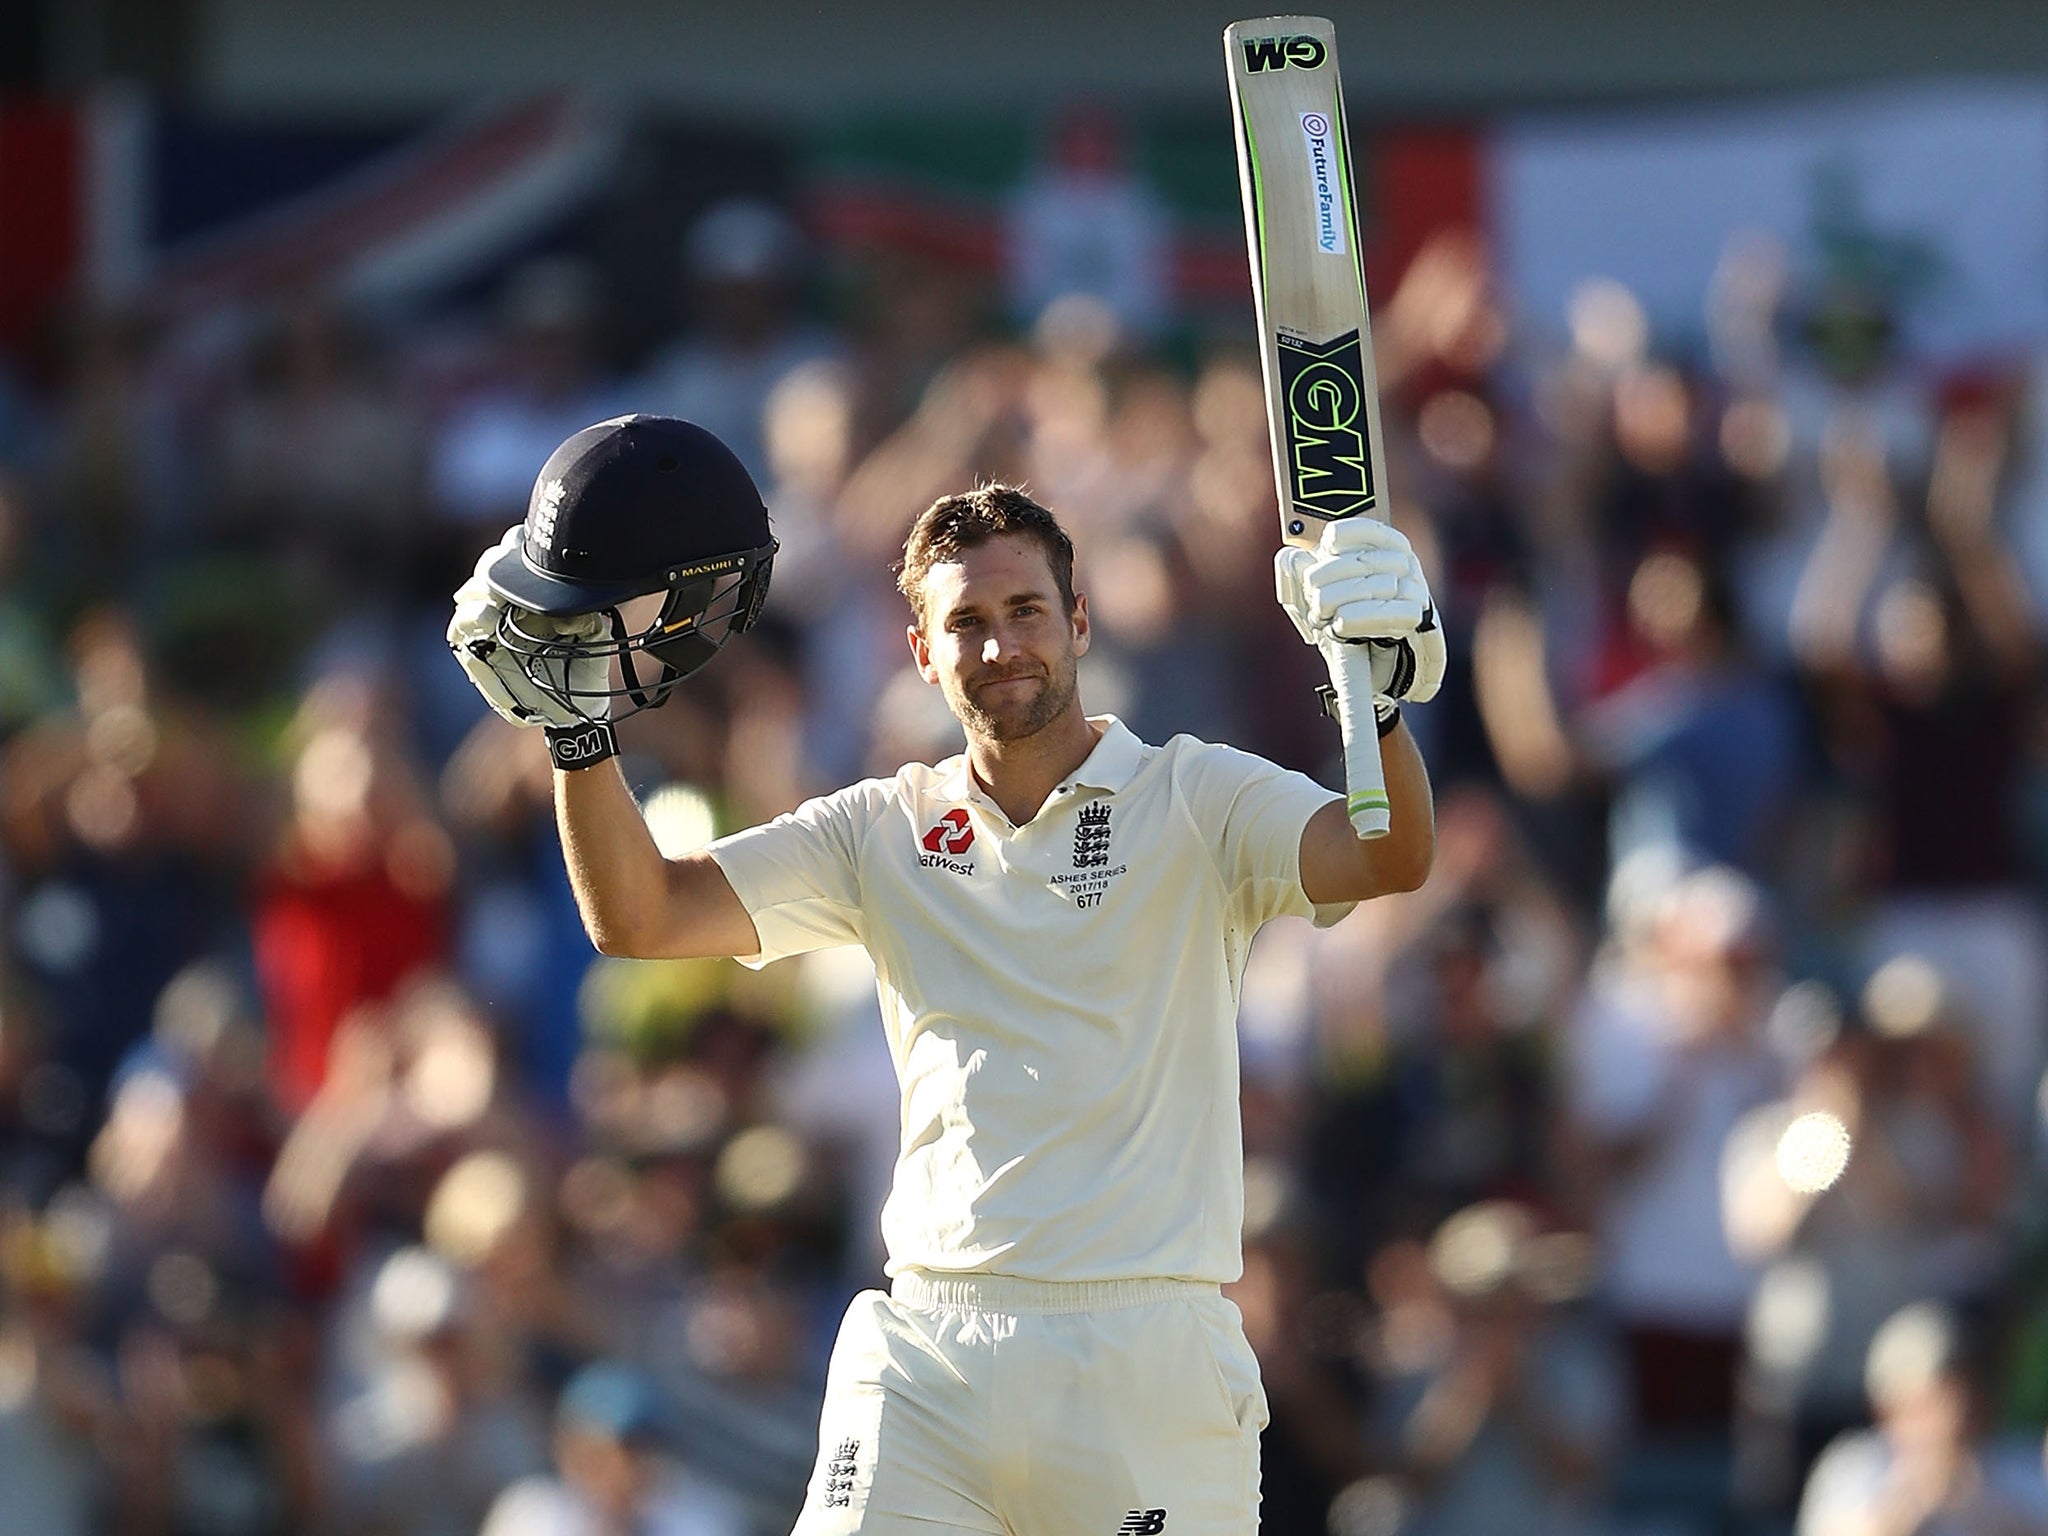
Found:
[1798,1303,2048,1536]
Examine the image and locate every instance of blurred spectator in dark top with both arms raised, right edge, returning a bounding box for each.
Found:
[1796,385,2048,1126]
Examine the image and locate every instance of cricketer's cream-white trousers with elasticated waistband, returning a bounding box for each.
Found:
[795,1274,1266,1536]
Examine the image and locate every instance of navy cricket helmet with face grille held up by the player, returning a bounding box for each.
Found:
[485,416,776,719]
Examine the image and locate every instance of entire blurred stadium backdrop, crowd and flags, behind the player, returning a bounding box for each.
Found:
[0,0,2048,1536]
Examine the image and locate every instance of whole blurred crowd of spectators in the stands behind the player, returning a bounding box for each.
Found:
[0,144,2048,1536]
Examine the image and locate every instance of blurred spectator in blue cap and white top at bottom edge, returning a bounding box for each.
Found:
[481,1362,748,1536]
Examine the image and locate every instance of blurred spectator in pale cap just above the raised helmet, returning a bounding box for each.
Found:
[633,199,838,483]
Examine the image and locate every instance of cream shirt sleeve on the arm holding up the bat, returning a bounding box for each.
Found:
[1180,739,1358,928]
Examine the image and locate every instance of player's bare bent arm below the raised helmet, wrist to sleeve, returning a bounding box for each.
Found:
[555,760,760,961]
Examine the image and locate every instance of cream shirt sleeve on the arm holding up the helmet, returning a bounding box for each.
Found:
[707,780,887,969]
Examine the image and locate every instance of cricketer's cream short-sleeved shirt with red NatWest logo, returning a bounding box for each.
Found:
[711,717,1350,1282]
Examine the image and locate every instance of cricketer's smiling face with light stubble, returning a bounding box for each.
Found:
[909,535,1087,741]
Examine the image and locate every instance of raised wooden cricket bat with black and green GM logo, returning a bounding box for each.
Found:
[1223,16,1389,838]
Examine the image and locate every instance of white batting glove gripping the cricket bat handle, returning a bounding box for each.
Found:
[1274,518,1448,705]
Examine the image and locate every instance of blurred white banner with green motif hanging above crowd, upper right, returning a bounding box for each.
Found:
[1489,84,2048,360]
